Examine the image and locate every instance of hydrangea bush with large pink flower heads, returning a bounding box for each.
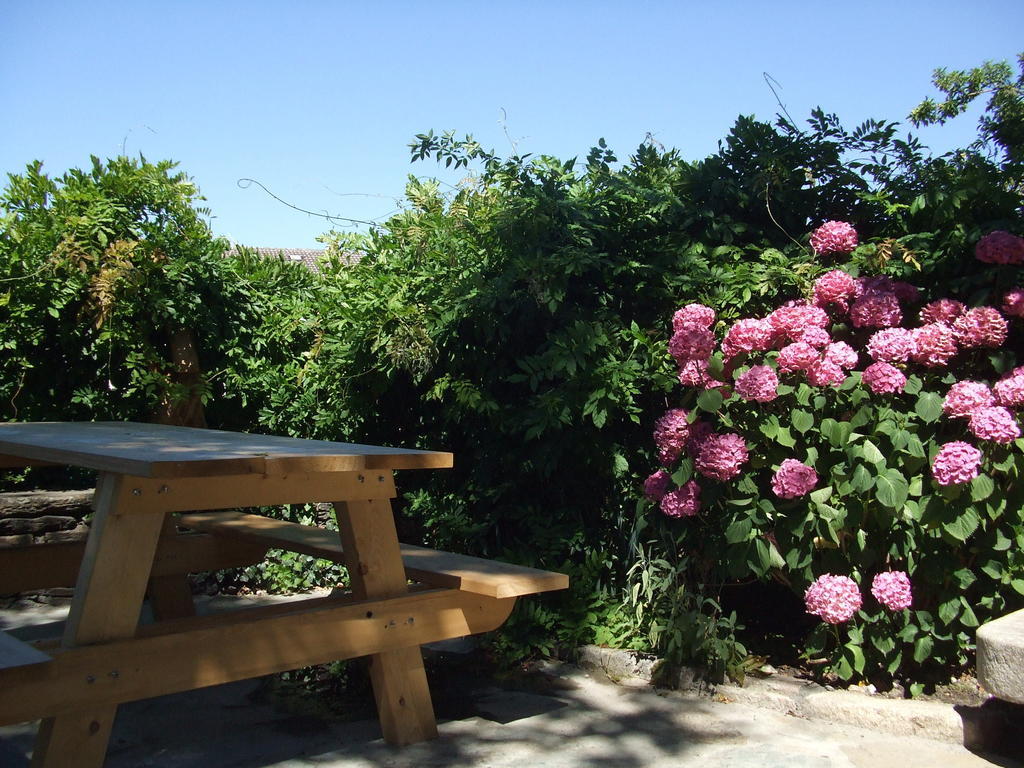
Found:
[644,221,1024,689]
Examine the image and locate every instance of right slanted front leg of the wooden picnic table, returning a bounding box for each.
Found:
[335,499,437,745]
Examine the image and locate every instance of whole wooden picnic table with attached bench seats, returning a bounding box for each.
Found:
[0,422,568,768]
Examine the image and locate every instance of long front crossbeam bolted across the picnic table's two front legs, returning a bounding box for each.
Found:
[0,590,515,729]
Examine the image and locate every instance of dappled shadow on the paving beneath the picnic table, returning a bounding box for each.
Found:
[0,663,737,768]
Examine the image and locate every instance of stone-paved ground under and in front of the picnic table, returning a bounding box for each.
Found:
[0,612,1024,768]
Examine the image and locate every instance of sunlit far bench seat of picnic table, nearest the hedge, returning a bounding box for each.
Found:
[177,512,569,598]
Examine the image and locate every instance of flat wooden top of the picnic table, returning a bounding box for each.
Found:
[0,422,453,477]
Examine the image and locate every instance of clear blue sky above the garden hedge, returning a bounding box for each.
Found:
[6,0,1024,248]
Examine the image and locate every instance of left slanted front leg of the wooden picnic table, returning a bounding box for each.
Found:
[32,473,164,768]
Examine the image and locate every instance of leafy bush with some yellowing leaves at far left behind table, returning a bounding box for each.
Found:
[0,158,224,420]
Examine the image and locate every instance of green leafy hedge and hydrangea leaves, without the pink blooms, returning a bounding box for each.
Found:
[8,57,1024,692]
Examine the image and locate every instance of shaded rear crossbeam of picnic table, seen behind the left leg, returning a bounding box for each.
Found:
[0,534,270,595]
